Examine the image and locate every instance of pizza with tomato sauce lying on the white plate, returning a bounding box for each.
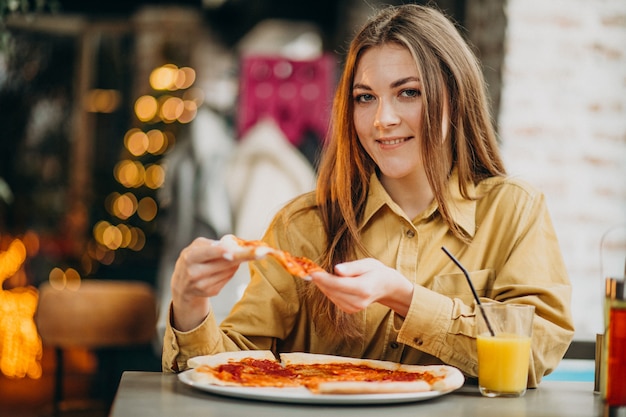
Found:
[189,351,465,394]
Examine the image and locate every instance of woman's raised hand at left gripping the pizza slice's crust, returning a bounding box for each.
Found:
[170,238,241,331]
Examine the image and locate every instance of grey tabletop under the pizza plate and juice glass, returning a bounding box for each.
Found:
[110,371,603,417]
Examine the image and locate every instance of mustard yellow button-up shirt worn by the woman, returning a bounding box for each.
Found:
[162,175,574,387]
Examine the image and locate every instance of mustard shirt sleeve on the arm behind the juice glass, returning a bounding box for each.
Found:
[398,186,574,387]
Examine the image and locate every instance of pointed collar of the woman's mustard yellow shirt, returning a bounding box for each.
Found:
[361,169,476,237]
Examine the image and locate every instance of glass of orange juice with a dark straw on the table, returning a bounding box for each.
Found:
[476,303,535,397]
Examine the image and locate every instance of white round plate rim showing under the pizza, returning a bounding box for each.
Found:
[178,369,451,405]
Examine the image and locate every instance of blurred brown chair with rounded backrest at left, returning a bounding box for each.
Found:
[35,279,157,416]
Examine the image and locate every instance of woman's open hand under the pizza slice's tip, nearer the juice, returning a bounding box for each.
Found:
[311,258,413,317]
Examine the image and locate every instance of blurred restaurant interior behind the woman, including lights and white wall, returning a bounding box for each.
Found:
[0,0,626,416]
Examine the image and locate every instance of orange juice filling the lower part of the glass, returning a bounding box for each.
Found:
[476,333,530,396]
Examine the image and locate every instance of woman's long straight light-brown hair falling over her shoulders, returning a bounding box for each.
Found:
[307,4,505,341]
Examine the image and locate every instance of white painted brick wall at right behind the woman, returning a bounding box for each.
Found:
[499,0,626,340]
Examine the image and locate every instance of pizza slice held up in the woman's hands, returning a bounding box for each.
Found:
[218,234,323,279]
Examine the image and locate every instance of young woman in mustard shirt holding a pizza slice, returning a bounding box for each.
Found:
[163,5,573,387]
